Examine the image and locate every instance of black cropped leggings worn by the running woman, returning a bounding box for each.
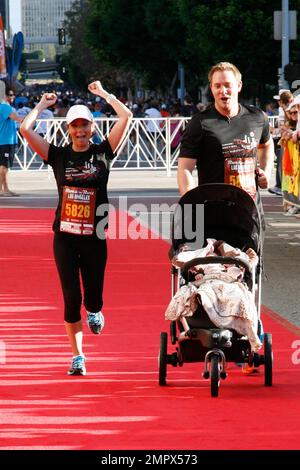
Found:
[53,233,107,323]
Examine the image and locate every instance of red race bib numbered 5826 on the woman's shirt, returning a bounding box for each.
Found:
[60,186,96,235]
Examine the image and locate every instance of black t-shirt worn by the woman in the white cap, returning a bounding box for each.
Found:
[47,140,114,235]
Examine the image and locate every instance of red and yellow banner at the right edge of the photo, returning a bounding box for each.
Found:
[282,140,300,207]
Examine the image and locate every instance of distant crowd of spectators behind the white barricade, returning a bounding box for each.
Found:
[9,83,205,159]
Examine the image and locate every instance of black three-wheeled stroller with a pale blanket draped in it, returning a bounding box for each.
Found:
[159,183,273,396]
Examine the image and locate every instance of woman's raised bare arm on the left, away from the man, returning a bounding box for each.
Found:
[20,93,57,161]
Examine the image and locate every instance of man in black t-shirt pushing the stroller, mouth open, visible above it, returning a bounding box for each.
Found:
[177,62,274,218]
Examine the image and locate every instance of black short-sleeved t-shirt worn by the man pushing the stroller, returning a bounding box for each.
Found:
[179,105,270,184]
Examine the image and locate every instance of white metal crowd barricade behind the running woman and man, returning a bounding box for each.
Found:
[13,116,278,176]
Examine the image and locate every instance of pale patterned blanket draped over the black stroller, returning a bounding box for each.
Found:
[165,239,262,352]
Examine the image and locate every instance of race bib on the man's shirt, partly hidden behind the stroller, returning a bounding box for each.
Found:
[224,157,256,199]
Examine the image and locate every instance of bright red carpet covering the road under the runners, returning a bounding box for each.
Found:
[0,209,300,450]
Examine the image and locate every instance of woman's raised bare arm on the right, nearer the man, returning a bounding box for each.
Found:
[88,81,132,152]
